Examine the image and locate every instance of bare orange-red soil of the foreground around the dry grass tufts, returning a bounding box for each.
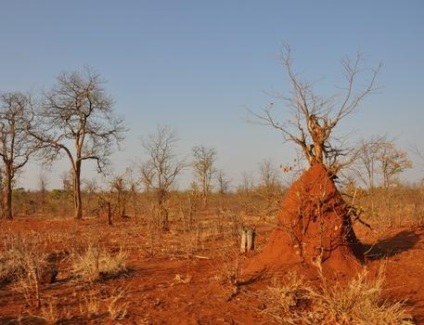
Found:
[0,215,424,324]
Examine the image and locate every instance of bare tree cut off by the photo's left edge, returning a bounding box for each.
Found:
[0,92,38,219]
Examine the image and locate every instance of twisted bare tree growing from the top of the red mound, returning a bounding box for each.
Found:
[251,46,381,174]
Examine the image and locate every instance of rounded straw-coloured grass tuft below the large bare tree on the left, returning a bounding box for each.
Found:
[72,244,128,282]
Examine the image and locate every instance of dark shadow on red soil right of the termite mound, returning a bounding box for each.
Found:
[363,230,420,261]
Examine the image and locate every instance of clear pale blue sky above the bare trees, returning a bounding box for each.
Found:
[0,0,424,188]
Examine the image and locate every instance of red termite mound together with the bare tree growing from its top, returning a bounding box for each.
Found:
[245,47,380,273]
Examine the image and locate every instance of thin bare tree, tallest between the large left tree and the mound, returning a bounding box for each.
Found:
[141,126,185,231]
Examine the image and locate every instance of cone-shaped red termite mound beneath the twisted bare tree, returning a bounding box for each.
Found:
[243,164,365,276]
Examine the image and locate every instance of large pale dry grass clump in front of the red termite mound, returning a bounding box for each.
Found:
[263,271,414,325]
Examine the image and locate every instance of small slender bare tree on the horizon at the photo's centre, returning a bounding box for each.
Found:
[192,146,216,207]
